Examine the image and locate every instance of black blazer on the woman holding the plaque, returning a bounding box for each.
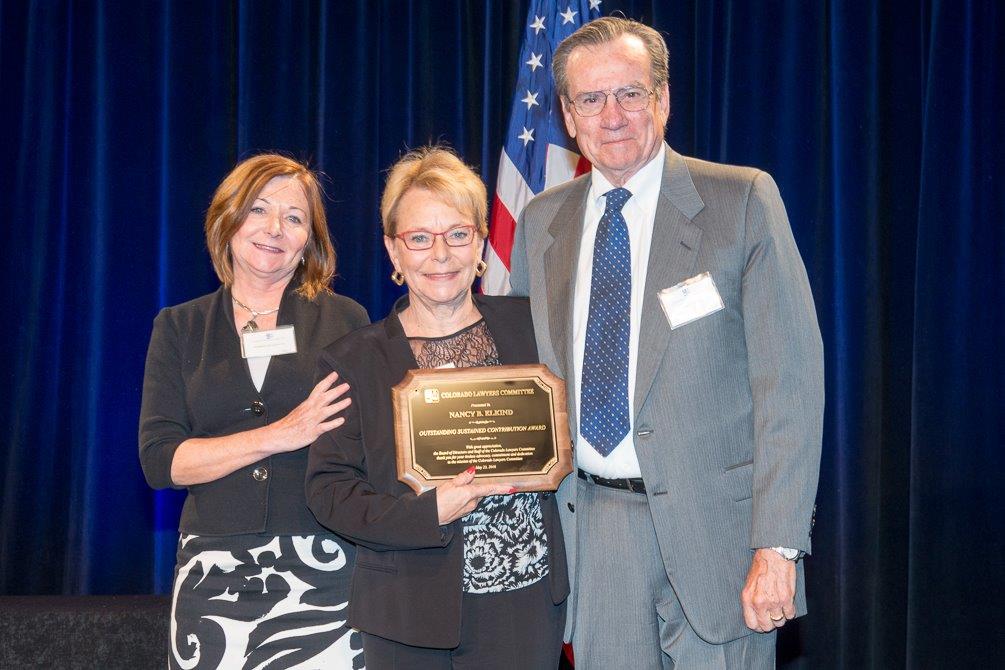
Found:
[307,295,569,649]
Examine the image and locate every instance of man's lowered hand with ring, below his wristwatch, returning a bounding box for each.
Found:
[740,548,796,633]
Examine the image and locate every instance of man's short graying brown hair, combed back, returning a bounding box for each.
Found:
[552,16,670,98]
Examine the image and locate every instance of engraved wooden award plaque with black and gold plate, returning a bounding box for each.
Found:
[391,364,572,493]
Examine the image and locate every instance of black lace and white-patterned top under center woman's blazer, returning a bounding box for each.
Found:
[409,320,548,594]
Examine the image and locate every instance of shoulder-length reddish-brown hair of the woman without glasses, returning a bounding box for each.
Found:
[206,154,336,300]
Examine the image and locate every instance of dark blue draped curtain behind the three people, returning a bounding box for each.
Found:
[0,0,1005,668]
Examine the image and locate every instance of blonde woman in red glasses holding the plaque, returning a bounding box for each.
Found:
[307,147,569,670]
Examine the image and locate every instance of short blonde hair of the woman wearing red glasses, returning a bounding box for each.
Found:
[380,145,488,239]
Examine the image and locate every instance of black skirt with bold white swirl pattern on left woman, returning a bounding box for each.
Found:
[169,533,363,670]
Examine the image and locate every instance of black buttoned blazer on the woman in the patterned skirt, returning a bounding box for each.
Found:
[140,281,370,535]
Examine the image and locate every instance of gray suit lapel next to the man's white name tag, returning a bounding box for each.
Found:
[635,149,705,414]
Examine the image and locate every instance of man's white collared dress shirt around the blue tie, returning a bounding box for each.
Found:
[572,144,666,479]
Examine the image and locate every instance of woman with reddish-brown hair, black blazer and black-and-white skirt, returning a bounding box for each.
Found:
[140,154,369,669]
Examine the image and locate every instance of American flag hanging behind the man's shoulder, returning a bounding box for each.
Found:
[481,0,603,295]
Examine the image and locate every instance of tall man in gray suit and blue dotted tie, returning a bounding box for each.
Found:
[511,17,823,670]
